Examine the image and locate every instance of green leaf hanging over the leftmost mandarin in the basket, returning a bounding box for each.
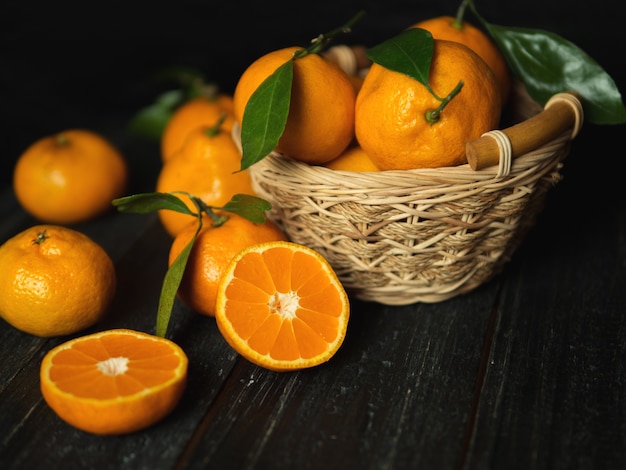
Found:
[241,59,293,170]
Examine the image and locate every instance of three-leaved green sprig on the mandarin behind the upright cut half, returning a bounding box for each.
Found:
[112,191,271,337]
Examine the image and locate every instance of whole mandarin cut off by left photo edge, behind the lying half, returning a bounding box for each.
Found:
[0,225,116,337]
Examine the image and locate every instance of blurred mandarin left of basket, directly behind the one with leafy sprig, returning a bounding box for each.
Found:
[156,123,254,237]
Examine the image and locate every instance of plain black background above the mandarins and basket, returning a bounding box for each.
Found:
[0,0,626,186]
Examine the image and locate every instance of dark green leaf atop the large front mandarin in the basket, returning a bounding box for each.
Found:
[366,28,435,93]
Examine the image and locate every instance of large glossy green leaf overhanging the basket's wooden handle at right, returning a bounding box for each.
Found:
[485,22,626,124]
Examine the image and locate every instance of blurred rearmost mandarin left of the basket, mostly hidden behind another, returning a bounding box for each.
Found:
[161,93,235,162]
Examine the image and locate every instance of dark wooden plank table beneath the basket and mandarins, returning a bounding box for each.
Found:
[0,2,626,470]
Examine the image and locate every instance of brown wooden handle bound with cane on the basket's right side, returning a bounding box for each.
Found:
[465,92,583,170]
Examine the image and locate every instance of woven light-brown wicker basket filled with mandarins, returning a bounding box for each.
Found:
[243,77,582,305]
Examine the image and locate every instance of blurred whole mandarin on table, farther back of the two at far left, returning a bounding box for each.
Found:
[13,129,128,224]
